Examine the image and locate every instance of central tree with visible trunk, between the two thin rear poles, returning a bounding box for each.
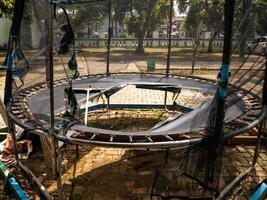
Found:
[114,0,170,53]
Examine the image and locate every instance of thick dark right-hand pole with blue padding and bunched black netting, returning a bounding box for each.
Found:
[205,0,235,194]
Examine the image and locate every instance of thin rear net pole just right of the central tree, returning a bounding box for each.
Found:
[164,0,173,110]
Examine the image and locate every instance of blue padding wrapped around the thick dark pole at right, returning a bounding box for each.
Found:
[219,64,229,99]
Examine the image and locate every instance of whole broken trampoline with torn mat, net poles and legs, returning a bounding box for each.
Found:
[2,0,267,199]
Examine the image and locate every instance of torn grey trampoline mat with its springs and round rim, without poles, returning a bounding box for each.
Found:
[8,73,261,149]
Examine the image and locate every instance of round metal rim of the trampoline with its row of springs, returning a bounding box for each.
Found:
[7,73,265,150]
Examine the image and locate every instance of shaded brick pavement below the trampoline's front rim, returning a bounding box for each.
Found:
[21,145,267,200]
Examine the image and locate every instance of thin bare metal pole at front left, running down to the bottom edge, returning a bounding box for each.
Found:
[49,3,63,200]
